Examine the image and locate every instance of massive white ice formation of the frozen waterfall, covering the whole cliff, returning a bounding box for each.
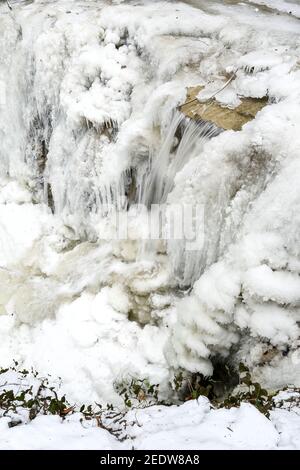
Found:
[0,0,300,401]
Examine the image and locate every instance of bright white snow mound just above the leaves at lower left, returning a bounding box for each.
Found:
[0,287,169,403]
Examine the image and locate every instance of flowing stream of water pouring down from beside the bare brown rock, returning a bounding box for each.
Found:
[138,111,221,287]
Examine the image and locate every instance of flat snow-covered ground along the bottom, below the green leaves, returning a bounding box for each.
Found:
[0,397,300,450]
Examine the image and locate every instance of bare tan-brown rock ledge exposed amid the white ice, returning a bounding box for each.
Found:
[180,86,268,131]
